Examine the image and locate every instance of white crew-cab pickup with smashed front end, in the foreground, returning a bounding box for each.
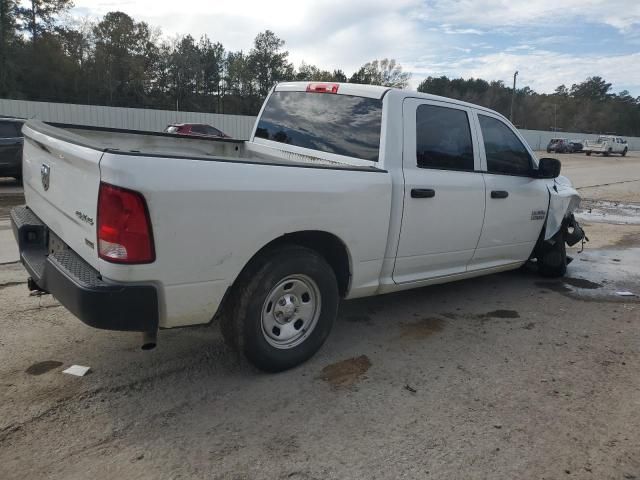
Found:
[11,82,584,371]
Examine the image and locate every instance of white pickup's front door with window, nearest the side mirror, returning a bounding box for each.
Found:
[469,112,549,270]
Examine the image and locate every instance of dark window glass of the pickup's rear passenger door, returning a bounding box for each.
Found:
[416,105,473,170]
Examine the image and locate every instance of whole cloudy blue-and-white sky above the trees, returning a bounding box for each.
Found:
[71,0,640,97]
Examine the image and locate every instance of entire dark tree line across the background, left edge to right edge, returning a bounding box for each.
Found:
[0,0,640,136]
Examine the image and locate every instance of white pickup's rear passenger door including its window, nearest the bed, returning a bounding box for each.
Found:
[393,98,485,283]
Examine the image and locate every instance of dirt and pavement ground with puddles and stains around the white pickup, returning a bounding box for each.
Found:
[0,155,640,480]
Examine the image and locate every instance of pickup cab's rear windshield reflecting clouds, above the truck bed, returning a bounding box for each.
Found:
[256,92,382,162]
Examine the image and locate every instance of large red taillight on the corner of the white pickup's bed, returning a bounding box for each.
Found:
[98,183,155,263]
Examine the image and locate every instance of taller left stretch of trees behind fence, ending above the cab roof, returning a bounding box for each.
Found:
[0,0,409,115]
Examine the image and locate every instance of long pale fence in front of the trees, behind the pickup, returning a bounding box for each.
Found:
[0,99,640,150]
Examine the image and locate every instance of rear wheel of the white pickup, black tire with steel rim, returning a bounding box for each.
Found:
[221,245,339,372]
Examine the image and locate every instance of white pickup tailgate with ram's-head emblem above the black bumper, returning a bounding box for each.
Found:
[23,121,103,270]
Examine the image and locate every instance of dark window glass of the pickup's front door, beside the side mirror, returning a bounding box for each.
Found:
[478,115,531,175]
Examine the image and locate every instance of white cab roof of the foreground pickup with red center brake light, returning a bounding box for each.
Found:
[274,82,506,120]
